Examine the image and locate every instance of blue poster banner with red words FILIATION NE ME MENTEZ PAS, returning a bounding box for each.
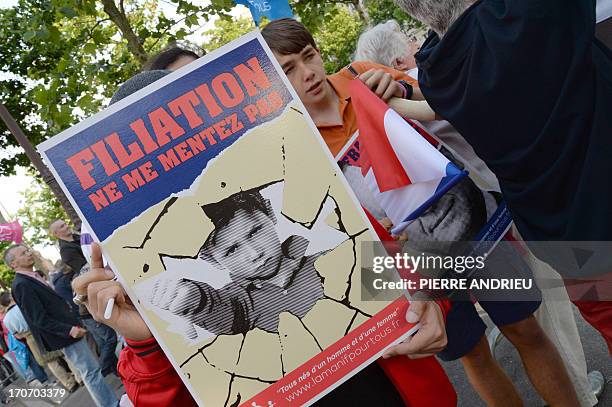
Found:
[45,39,291,240]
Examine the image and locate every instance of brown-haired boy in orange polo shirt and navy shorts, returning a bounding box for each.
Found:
[262,19,578,406]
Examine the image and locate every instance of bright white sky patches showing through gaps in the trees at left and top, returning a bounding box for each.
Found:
[0,0,250,261]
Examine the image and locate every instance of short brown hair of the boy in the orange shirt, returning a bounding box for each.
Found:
[261,18,318,55]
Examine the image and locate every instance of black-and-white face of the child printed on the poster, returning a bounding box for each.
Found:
[211,209,282,280]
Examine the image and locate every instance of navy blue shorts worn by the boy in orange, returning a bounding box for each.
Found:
[438,244,542,361]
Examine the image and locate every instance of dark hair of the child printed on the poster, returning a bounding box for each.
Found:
[199,187,275,260]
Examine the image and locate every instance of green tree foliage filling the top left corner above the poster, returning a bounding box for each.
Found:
[0,0,233,175]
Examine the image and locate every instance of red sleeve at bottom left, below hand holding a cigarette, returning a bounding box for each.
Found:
[118,338,197,407]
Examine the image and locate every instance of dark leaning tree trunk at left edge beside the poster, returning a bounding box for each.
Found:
[0,103,81,229]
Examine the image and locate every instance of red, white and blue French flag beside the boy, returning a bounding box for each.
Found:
[340,79,467,235]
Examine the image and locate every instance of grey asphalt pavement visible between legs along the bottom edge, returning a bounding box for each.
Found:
[4,310,612,407]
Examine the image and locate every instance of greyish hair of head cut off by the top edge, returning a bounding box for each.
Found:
[395,0,475,36]
